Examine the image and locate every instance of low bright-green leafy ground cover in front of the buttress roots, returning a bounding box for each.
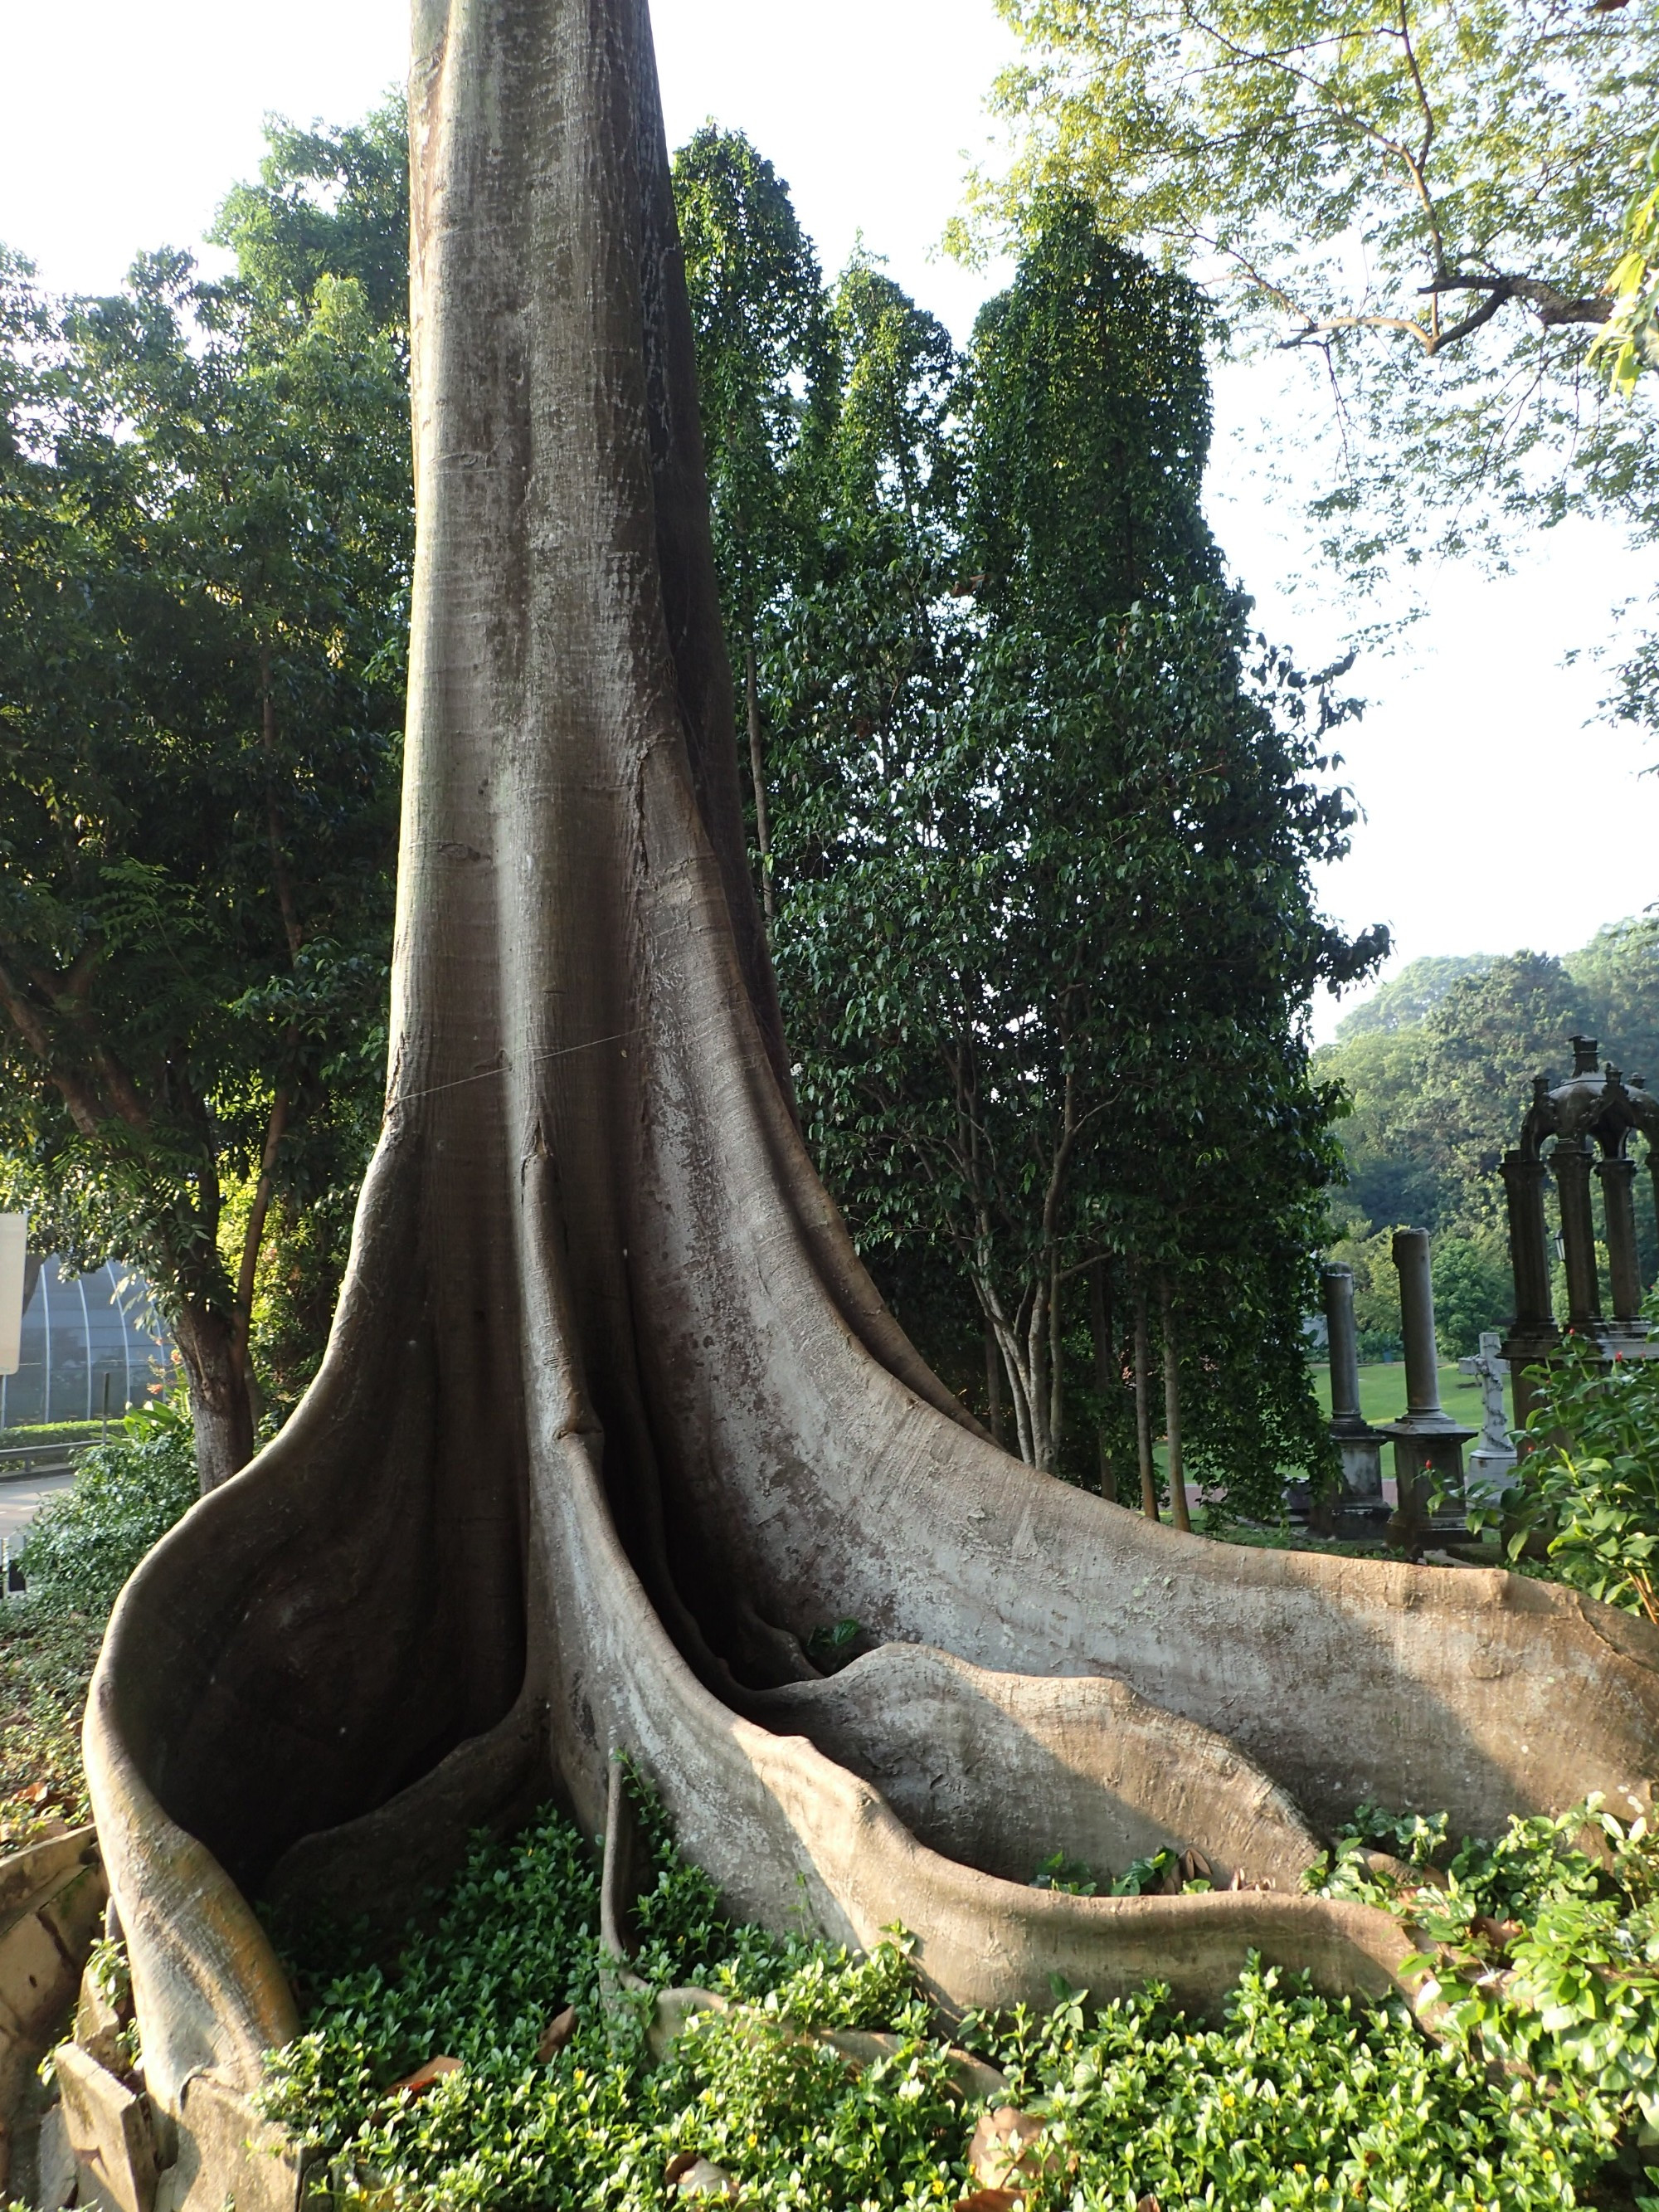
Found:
[240,1778,1659,2212]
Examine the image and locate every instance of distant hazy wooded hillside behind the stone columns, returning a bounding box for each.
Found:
[1314,916,1659,1358]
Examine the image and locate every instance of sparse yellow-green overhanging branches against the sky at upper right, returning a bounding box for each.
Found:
[969,0,1659,588]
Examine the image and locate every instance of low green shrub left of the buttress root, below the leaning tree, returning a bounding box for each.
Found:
[20,1405,199,1620]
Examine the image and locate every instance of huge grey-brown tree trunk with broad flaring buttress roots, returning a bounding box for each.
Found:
[86,0,1659,2159]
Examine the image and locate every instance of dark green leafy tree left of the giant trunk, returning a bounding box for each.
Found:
[0,110,411,1475]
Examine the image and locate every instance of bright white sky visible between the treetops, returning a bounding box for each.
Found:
[0,0,1659,1033]
